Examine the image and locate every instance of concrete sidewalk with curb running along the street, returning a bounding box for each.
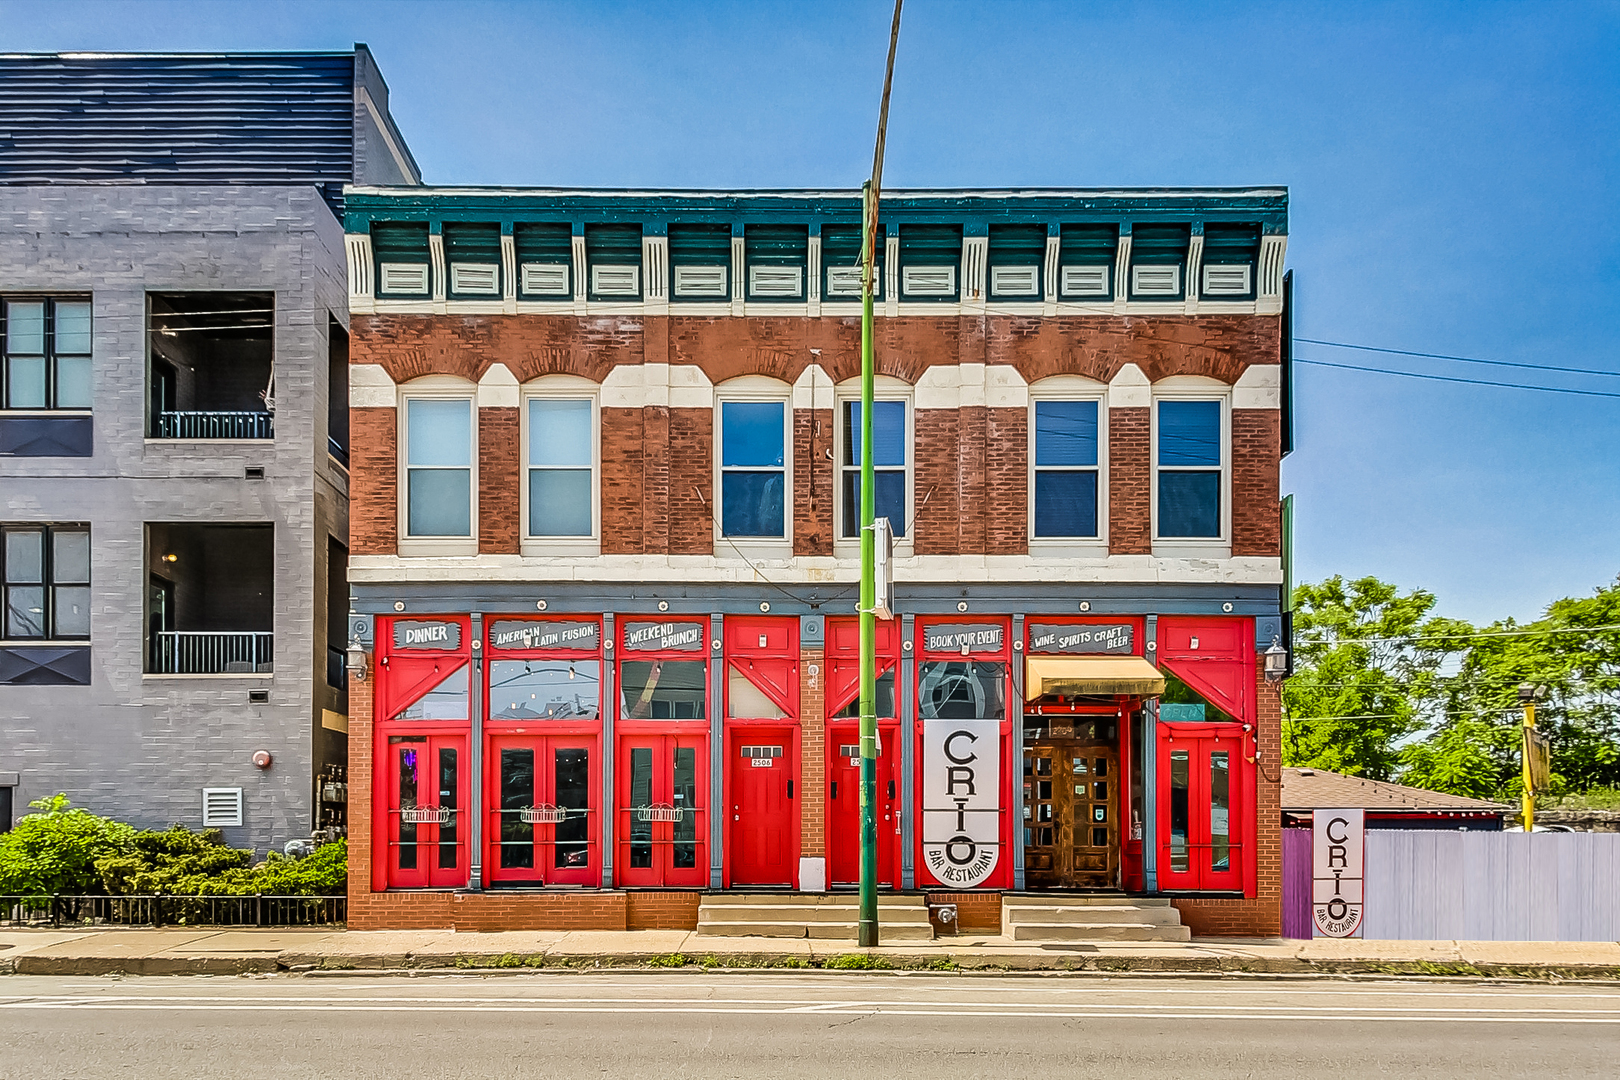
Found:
[0,929,1620,980]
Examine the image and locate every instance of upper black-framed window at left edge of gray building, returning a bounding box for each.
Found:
[0,300,91,410]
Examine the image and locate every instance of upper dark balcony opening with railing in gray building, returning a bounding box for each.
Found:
[147,293,275,439]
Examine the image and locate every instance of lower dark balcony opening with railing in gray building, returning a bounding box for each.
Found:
[146,523,275,675]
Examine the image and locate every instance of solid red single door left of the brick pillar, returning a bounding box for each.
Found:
[729,725,799,886]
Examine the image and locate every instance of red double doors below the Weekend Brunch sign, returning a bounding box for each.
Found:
[617,732,710,889]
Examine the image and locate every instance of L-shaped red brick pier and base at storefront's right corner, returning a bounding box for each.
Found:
[1175,670,1283,938]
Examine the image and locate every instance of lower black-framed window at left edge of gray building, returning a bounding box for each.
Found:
[0,525,91,640]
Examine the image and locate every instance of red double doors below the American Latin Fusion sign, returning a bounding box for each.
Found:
[484,733,601,886]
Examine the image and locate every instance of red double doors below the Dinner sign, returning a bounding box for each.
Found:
[384,735,467,889]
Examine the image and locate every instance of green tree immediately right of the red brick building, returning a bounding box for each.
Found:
[1283,575,1471,780]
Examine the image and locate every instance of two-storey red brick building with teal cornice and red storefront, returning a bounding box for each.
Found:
[347,188,1286,934]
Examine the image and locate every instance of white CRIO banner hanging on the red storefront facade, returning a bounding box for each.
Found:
[922,721,1001,889]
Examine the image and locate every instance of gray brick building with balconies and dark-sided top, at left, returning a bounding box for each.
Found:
[0,45,420,852]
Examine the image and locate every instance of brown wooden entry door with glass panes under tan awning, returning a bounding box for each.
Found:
[1024,738,1119,889]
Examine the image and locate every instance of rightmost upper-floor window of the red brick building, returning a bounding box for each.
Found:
[1157,402,1223,539]
